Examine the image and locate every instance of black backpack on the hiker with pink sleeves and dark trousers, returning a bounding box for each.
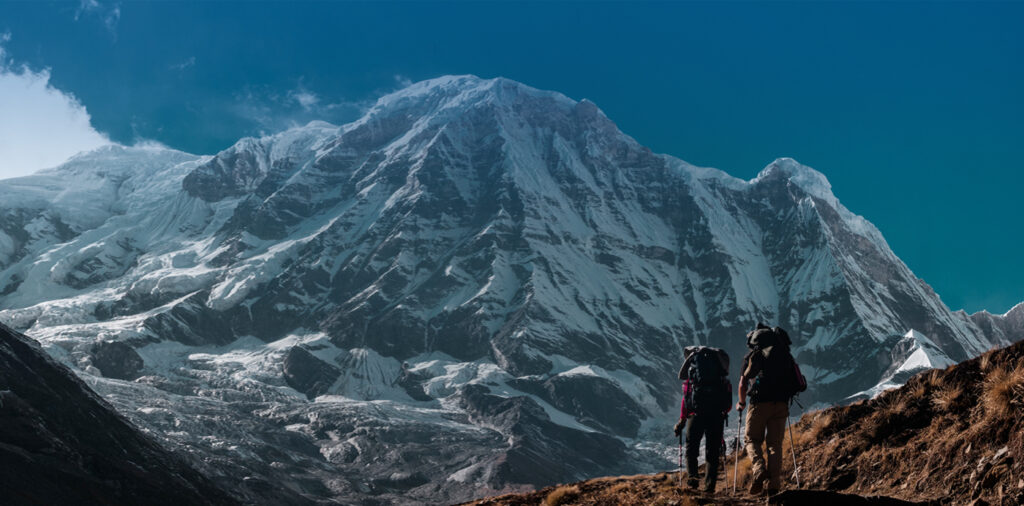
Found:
[679,346,732,416]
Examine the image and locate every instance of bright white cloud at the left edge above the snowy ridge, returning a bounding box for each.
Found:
[0,33,111,178]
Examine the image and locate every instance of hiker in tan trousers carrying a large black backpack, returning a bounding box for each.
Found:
[736,323,807,495]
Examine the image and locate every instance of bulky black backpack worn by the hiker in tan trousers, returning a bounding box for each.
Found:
[743,324,807,403]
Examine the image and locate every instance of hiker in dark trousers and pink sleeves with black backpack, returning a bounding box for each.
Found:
[675,346,732,494]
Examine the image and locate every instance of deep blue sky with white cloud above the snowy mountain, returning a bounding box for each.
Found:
[0,0,1024,312]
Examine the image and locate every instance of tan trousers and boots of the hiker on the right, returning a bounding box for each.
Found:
[743,403,790,490]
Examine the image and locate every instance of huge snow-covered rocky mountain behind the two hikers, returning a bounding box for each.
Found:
[0,76,1024,502]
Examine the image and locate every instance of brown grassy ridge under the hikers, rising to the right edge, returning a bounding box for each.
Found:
[472,341,1024,506]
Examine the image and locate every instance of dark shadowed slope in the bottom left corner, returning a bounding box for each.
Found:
[0,324,237,505]
